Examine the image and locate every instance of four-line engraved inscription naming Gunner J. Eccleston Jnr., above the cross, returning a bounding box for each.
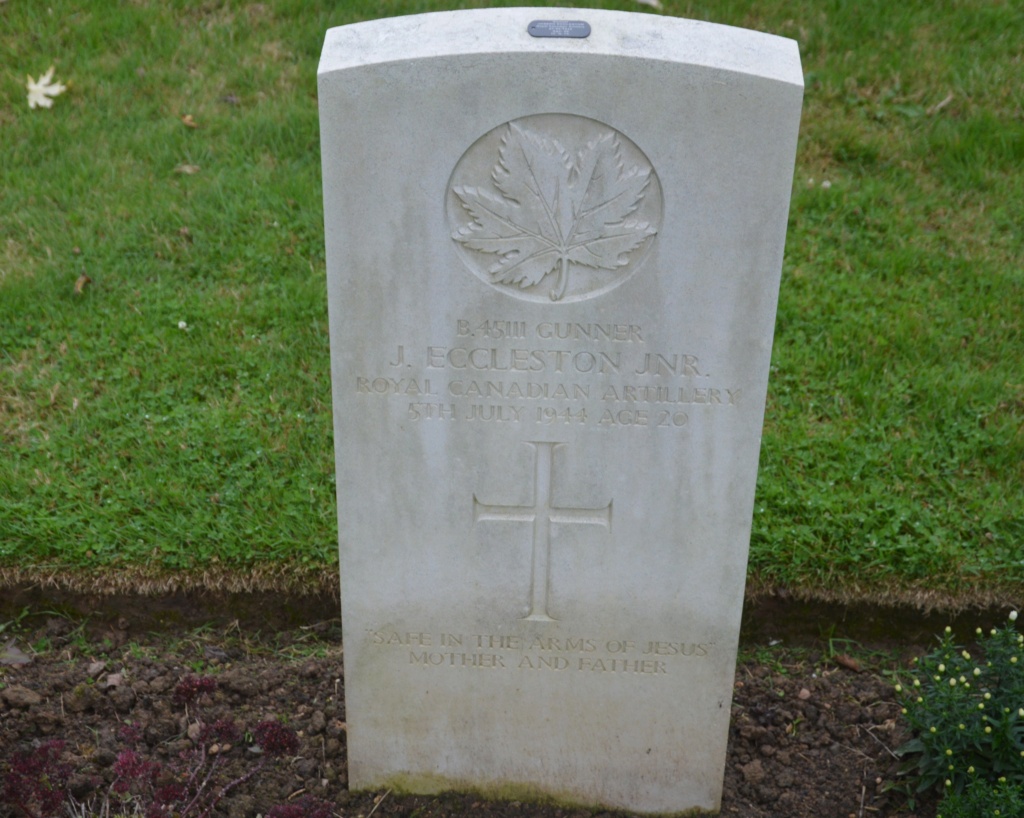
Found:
[354,315,744,434]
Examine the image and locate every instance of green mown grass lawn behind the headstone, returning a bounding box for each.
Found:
[0,0,1024,604]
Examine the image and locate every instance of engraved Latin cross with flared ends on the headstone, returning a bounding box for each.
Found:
[473,441,611,622]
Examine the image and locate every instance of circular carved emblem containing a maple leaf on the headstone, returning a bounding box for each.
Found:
[445,114,663,303]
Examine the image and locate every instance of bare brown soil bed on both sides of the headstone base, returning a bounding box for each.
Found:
[0,616,935,818]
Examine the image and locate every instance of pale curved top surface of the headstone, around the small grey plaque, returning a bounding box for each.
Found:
[317,7,804,88]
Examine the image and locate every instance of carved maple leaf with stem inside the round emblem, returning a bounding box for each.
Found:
[452,124,657,301]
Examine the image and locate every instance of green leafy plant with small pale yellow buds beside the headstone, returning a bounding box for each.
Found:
[896,611,1024,798]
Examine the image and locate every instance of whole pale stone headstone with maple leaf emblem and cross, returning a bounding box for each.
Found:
[319,8,803,813]
